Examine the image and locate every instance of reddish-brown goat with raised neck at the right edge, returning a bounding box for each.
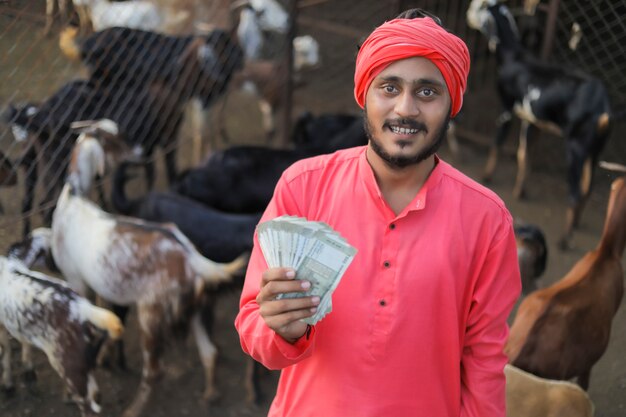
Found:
[504,166,626,389]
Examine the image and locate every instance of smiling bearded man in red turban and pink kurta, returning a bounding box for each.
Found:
[235,11,520,417]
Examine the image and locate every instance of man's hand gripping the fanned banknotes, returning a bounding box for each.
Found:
[256,268,320,343]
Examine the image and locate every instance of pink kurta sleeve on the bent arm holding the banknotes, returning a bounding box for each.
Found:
[235,171,315,369]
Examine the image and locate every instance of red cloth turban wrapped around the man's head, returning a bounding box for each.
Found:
[354,17,469,117]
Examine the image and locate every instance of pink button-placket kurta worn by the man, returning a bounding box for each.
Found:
[235,147,521,417]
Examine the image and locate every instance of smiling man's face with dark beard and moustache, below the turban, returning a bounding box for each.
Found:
[365,57,451,169]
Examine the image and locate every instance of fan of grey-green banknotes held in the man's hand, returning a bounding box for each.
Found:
[257,216,357,325]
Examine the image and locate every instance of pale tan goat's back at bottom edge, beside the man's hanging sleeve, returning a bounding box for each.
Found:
[504,364,594,417]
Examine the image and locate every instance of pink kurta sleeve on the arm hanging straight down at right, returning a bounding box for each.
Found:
[461,213,521,417]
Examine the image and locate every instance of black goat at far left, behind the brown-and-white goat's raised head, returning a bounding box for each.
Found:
[4,80,182,237]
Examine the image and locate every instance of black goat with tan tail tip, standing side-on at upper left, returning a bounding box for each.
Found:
[61,22,243,162]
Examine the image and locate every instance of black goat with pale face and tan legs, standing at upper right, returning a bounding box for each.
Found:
[467,0,612,249]
